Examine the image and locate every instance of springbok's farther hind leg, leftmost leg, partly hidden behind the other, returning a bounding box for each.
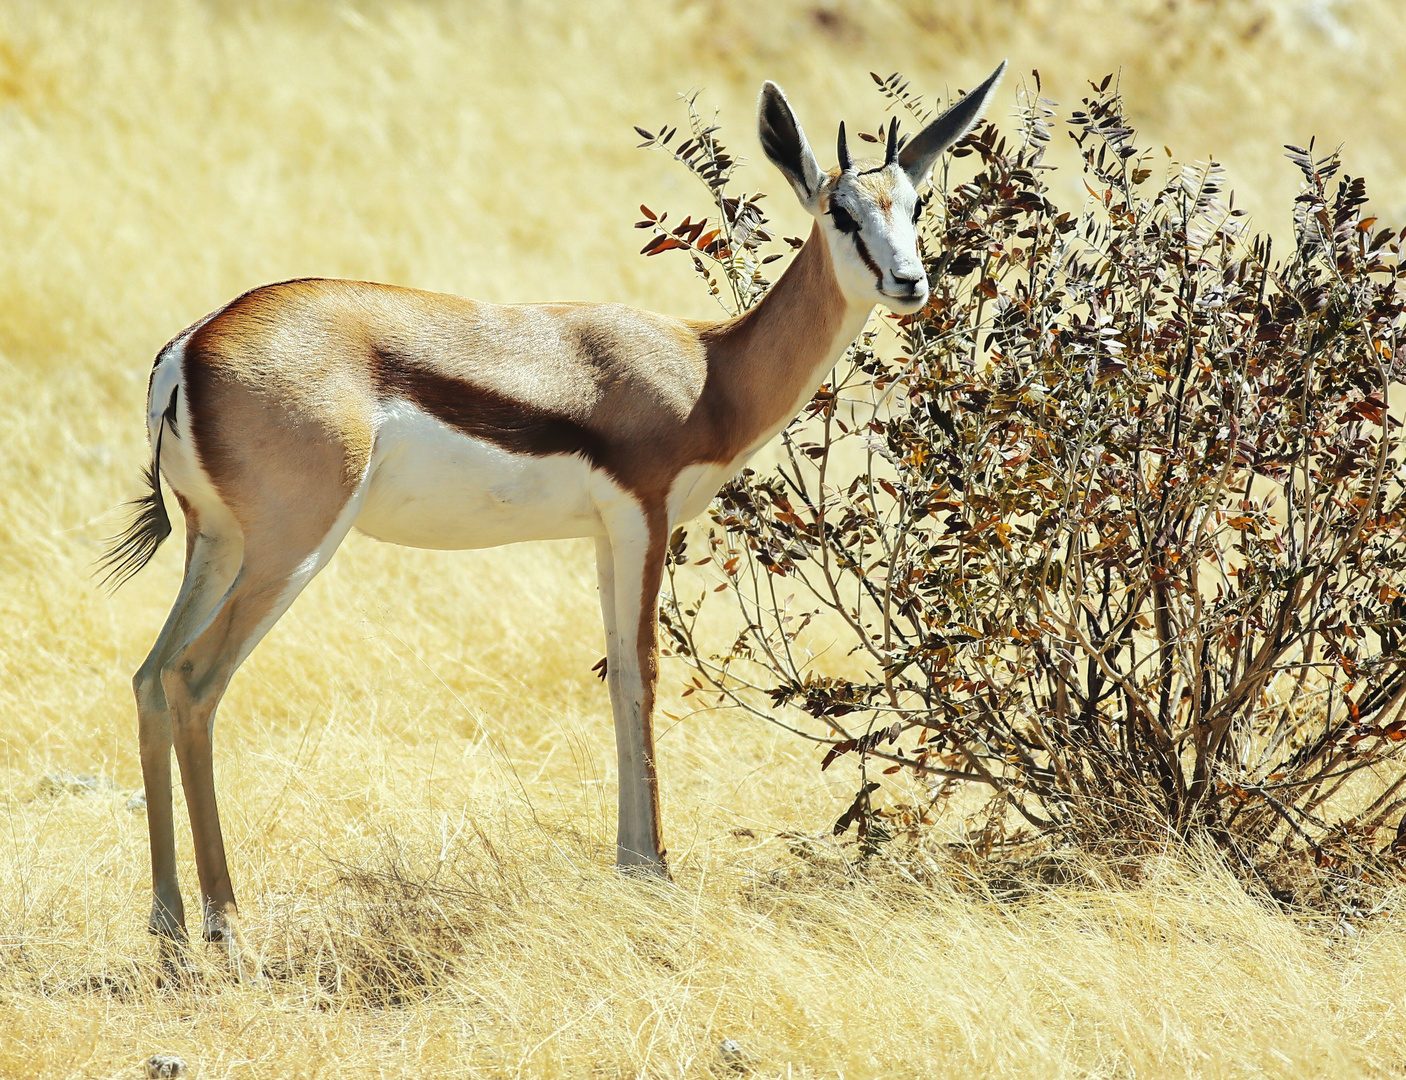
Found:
[132,513,242,959]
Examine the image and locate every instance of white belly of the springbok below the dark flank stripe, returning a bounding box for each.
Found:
[356,401,603,548]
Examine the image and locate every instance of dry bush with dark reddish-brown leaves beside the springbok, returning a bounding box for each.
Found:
[652,75,1406,904]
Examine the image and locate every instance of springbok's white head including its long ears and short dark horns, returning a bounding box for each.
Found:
[756,60,1005,314]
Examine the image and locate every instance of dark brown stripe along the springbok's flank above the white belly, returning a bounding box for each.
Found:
[371,346,610,471]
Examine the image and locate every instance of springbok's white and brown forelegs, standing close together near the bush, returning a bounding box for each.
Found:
[596,505,669,878]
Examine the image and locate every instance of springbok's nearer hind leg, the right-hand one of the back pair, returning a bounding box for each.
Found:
[162,483,361,976]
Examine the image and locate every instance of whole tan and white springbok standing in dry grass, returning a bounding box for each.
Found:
[104,63,1005,951]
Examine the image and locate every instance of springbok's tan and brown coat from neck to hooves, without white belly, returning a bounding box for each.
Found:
[135,225,866,953]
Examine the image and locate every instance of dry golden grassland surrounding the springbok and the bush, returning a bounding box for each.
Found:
[0,0,1406,1079]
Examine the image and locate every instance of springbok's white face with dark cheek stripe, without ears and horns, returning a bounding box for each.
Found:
[813,162,928,315]
